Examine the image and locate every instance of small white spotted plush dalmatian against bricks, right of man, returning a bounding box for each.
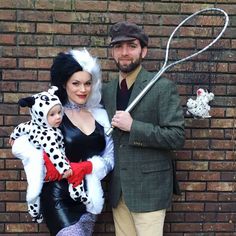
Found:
[187,88,214,118]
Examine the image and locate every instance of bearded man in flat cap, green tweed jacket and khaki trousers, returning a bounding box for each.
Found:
[103,22,184,236]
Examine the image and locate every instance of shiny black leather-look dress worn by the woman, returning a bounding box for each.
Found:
[41,115,105,235]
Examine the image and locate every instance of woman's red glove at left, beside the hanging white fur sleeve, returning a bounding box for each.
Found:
[43,152,62,181]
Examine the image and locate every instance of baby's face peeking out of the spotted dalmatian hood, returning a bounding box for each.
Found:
[47,104,63,128]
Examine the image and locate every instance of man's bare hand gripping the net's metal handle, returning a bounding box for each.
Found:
[111,111,133,132]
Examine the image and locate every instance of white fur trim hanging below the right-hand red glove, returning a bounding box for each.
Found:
[85,173,104,215]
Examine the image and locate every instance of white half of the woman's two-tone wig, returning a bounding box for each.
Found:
[69,48,102,108]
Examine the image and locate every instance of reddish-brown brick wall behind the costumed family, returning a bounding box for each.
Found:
[0,0,236,236]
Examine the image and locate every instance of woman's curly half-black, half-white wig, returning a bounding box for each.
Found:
[51,49,102,108]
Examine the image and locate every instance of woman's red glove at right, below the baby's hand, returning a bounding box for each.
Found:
[67,161,93,188]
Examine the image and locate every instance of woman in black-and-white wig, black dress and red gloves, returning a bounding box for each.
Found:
[13,49,114,236]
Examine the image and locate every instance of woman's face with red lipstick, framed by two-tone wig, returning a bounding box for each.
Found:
[65,71,92,105]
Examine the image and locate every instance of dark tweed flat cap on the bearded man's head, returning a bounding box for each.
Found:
[109,21,148,46]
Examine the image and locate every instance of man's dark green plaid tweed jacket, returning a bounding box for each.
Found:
[103,68,185,212]
